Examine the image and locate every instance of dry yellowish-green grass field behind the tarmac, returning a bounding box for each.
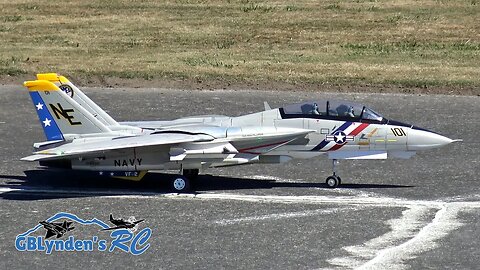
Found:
[0,0,480,87]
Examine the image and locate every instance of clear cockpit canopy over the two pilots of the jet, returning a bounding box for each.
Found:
[283,100,383,121]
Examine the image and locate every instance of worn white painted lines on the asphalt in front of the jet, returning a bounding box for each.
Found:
[0,187,480,269]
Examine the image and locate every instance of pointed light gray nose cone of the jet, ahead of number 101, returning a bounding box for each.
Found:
[407,127,454,150]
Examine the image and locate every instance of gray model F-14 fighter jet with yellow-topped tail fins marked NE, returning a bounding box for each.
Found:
[22,73,456,192]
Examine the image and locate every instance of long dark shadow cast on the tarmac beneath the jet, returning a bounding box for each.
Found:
[0,170,414,200]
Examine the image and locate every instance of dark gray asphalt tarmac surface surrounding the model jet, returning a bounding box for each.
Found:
[0,86,480,269]
